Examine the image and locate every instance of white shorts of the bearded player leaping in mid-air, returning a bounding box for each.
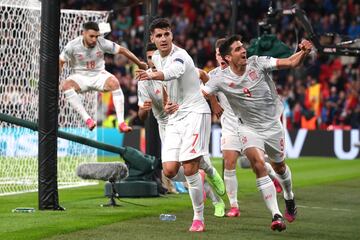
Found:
[67,70,114,92]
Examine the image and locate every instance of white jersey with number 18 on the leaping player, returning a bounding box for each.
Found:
[60,36,120,77]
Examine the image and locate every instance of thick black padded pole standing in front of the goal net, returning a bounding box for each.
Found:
[38,0,62,210]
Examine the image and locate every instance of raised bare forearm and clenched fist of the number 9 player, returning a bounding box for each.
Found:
[276,40,312,69]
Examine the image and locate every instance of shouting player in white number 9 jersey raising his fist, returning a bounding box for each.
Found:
[203,36,312,231]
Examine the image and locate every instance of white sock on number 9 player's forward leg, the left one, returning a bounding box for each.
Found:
[256,176,282,216]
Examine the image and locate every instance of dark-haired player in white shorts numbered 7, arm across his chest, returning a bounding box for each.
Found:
[138,18,211,232]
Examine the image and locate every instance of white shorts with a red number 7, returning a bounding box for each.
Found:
[161,112,211,162]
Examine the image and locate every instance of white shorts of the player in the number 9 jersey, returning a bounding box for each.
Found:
[238,121,285,163]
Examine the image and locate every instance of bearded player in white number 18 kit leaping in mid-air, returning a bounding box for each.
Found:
[59,22,147,132]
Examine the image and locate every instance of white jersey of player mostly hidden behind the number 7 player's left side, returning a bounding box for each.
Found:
[138,69,169,125]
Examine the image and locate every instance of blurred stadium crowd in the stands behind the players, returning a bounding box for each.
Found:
[61,0,360,130]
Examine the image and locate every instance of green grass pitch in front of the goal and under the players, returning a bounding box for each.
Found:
[0,158,360,240]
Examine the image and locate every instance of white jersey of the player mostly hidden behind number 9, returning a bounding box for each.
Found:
[209,67,239,135]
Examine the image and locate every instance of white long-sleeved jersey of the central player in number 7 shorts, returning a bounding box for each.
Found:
[152,44,210,122]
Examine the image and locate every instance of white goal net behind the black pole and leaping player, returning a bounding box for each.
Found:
[0,0,108,196]
